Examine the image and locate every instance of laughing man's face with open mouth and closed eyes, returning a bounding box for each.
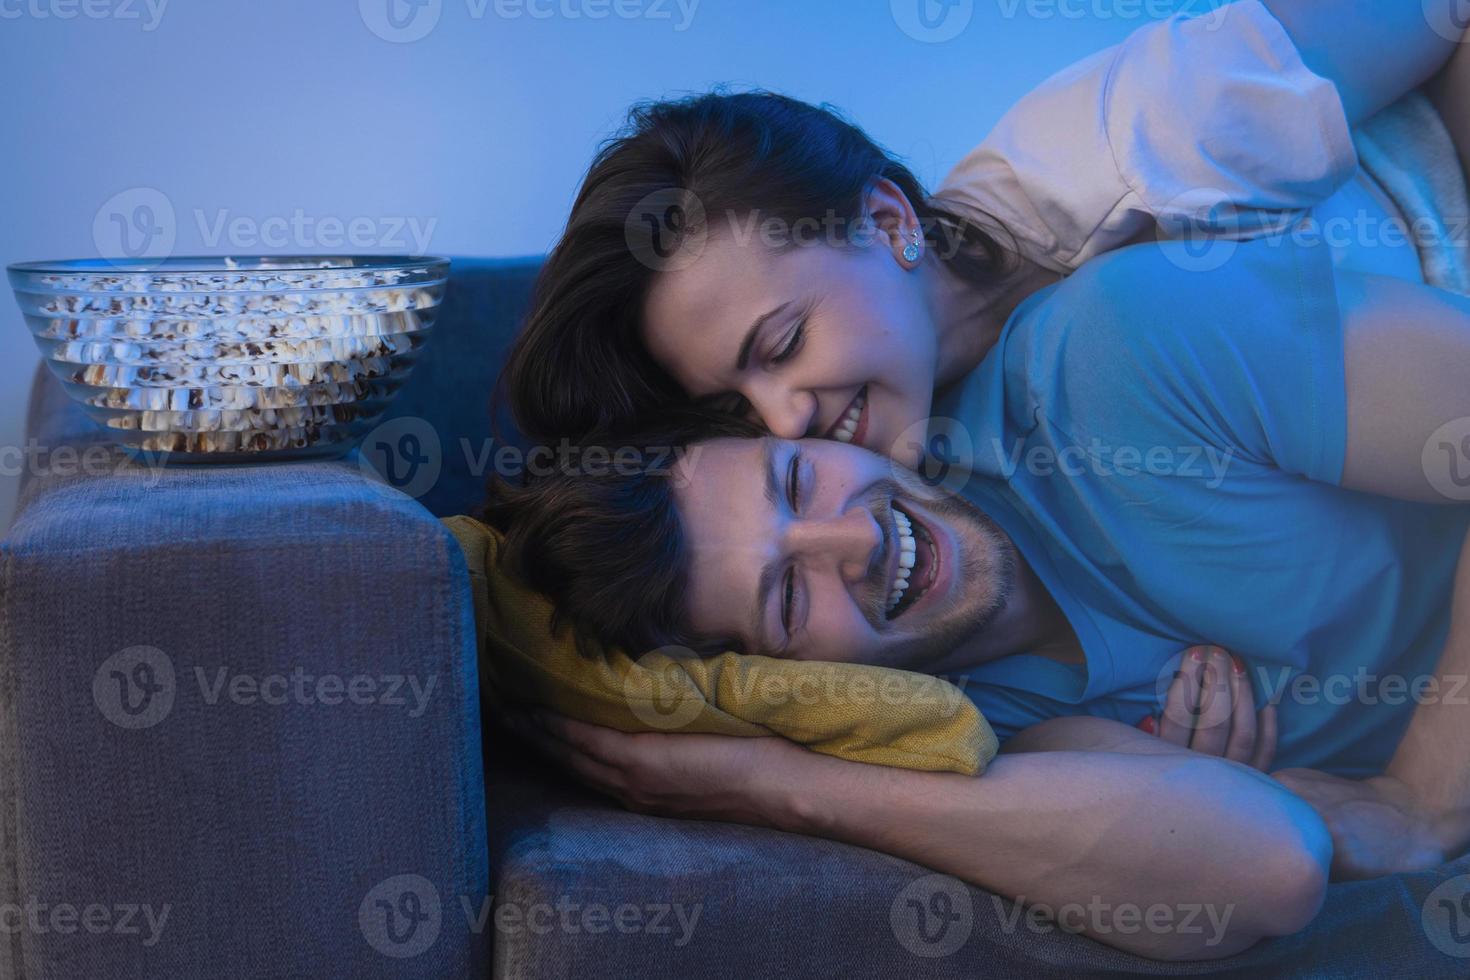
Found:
[675,438,1016,670]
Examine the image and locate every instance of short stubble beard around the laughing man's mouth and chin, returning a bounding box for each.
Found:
[875,466,1016,670]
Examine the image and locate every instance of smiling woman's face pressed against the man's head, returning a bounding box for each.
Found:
[642,216,938,466]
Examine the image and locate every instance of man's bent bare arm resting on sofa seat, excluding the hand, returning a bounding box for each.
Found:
[779,739,1330,959]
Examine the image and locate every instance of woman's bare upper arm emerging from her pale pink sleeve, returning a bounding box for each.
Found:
[1261,0,1458,126]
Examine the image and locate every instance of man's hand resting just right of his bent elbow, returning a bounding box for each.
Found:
[1272,768,1448,880]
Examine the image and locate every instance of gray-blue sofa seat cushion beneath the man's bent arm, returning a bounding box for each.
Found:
[487,732,1470,980]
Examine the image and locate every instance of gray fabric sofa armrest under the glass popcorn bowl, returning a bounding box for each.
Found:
[0,379,490,979]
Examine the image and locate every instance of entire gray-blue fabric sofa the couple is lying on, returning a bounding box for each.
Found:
[0,259,1470,980]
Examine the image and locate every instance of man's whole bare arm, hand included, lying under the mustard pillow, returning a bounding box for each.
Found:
[519,716,1332,959]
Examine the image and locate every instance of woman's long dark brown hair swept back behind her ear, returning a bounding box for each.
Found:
[497,91,1008,439]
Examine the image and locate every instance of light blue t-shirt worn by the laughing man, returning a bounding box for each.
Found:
[935,239,1470,776]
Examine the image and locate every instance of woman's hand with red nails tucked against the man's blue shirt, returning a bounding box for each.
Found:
[1138,646,1276,771]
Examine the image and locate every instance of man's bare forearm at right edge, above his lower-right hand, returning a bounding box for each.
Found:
[1386,525,1470,858]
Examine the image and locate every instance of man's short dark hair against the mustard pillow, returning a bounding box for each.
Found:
[479,407,763,657]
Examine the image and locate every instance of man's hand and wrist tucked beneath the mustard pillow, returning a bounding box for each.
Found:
[506,710,813,827]
